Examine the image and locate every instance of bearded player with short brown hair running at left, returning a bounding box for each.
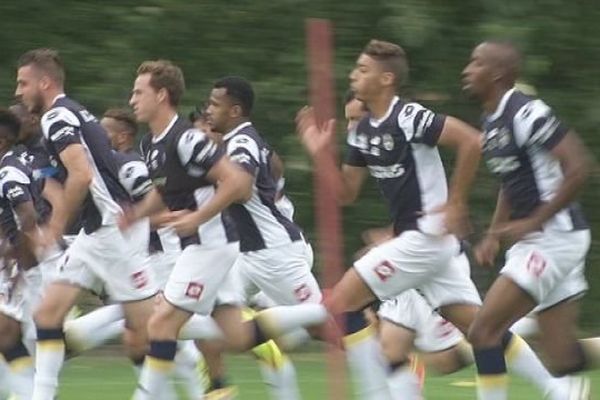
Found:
[15,49,157,400]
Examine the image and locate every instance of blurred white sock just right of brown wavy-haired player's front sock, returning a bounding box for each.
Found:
[175,340,204,399]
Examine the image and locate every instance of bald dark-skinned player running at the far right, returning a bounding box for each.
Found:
[463,42,600,400]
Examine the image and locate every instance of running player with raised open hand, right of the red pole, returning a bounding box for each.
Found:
[263,40,576,399]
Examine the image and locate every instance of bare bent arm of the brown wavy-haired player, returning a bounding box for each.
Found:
[170,157,254,236]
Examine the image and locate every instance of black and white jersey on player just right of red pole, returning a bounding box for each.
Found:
[345,97,448,234]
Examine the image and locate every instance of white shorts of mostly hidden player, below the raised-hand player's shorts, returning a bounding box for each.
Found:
[379,290,464,353]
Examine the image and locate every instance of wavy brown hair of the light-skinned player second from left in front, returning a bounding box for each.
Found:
[137,60,185,107]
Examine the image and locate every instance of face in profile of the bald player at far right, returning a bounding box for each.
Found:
[462,43,493,98]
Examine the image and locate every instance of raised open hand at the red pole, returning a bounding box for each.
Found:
[296,107,335,157]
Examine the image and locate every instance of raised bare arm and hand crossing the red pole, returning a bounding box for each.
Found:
[296,107,367,205]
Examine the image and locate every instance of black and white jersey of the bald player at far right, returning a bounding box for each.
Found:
[482,89,588,231]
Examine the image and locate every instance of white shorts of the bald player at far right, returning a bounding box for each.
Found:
[500,230,591,311]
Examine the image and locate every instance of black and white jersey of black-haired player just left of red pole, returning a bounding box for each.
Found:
[223,122,302,252]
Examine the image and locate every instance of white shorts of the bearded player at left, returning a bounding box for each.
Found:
[55,225,158,302]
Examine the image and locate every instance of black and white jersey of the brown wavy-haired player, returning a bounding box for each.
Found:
[140,115,238,248]
